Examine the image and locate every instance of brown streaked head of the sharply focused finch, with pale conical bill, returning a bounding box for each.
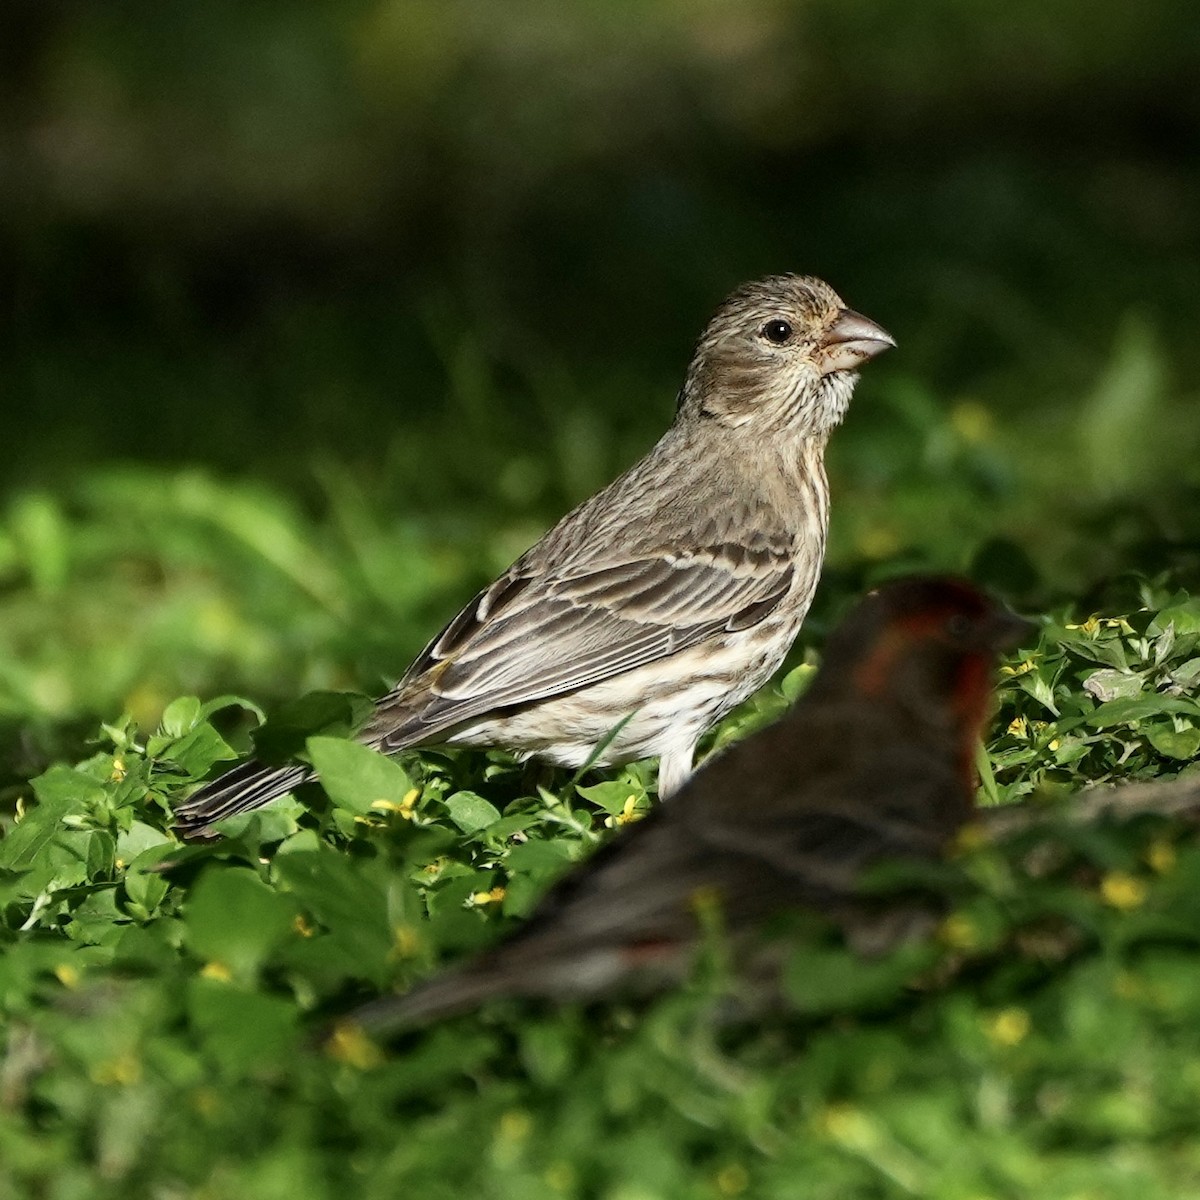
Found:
[679,275,895,434]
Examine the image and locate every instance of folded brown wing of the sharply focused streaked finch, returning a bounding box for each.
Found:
[364,539,793,750]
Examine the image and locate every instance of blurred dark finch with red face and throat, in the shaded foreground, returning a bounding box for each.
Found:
[343,577,1028,1028]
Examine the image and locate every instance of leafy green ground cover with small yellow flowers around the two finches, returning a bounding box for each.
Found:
[0,581,1200,1200]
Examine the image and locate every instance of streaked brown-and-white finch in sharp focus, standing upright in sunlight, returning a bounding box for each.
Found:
[176,275,895,834]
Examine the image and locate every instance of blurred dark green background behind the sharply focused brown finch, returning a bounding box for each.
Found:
[0,0,1200,769]
